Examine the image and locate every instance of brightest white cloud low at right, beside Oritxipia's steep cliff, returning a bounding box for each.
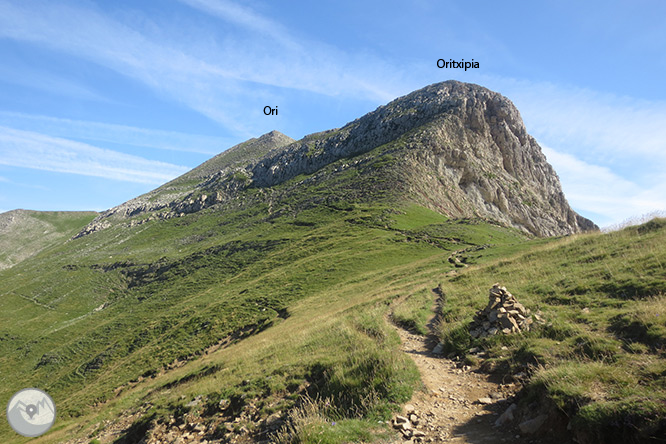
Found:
[542,146,666,225]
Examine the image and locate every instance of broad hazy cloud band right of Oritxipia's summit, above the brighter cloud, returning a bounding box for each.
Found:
[497,79,666,166]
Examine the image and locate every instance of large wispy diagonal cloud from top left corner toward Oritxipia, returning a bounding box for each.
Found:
[0,0,398,136]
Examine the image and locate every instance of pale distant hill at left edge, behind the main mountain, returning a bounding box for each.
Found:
[0,210,97,269]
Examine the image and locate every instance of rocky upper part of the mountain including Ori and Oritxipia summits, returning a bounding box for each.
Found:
[79,81,597,236]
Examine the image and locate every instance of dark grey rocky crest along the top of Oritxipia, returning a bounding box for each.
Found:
[246,80,528,186]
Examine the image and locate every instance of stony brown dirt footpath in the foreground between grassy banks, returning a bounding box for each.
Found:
[395,294,543,444]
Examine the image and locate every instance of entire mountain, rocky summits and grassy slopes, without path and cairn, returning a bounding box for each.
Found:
[0,82,666,444]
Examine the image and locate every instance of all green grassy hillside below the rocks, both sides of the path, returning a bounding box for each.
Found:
[0,199,666,442]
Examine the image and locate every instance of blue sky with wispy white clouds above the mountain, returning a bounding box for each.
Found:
[0,0,666,226]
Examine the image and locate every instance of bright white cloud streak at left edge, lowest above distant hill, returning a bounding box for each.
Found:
[0,127,187,184]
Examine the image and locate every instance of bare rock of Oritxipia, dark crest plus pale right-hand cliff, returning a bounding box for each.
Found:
[248,81,597,236]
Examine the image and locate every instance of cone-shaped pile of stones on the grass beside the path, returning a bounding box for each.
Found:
[469,284,543,338]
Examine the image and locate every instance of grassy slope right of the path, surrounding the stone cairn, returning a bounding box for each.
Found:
[441,219,666,442]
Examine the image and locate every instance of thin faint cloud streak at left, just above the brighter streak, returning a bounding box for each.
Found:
[0,111,228,155]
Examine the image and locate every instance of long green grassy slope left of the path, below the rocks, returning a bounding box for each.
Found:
[0,198,522,442]
